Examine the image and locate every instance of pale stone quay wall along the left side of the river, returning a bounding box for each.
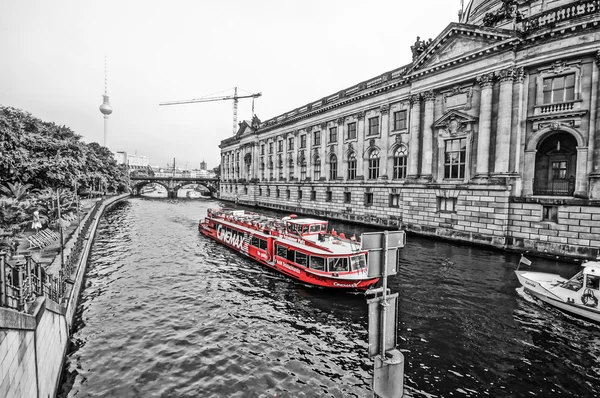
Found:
[0,194,129,398]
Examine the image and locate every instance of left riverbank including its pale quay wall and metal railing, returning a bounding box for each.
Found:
[0,194,129,398]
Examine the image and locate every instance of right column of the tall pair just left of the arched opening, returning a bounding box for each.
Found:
[494,68,515,174]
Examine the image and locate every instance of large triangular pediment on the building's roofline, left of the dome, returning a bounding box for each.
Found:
[412,23,518,71]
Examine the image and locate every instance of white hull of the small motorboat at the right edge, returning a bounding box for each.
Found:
[515,271,600,323]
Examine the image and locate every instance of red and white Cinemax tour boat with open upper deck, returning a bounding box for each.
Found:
[198,209,379,290]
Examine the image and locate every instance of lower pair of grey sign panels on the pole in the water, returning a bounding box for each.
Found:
[367,293,398,358]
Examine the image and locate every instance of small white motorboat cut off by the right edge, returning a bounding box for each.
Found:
[515,257,600,323]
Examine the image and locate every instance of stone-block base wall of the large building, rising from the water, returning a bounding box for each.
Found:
[220,182,600,260]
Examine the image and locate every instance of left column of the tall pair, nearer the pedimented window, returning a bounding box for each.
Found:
[475,73,494,179]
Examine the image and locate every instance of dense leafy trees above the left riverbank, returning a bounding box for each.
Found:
[0,106,129,235]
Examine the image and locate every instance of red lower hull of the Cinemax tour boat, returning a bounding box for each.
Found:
[199,224,379,291]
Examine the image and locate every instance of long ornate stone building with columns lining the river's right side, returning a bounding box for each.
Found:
[220,0,600,258]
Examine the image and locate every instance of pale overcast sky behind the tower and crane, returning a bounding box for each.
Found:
[0,0,468,169]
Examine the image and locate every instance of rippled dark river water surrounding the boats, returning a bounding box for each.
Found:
[60,198,600,398]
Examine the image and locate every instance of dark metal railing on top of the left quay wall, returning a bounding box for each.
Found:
[0,200,102,312]
